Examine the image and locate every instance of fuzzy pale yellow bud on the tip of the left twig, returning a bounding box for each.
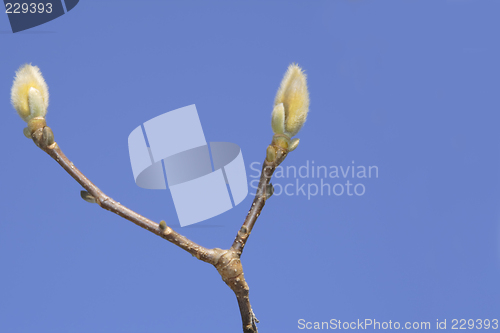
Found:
[10,64,49,122]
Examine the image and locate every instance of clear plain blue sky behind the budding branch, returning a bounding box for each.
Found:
[0,0,500,333]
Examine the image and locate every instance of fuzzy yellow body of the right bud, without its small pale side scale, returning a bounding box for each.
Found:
[274,64,309,138]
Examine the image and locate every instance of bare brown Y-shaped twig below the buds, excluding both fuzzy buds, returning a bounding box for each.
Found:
[31,125,287,333]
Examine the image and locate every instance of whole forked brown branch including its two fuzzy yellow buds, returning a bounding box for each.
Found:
[11,64,309,333]
